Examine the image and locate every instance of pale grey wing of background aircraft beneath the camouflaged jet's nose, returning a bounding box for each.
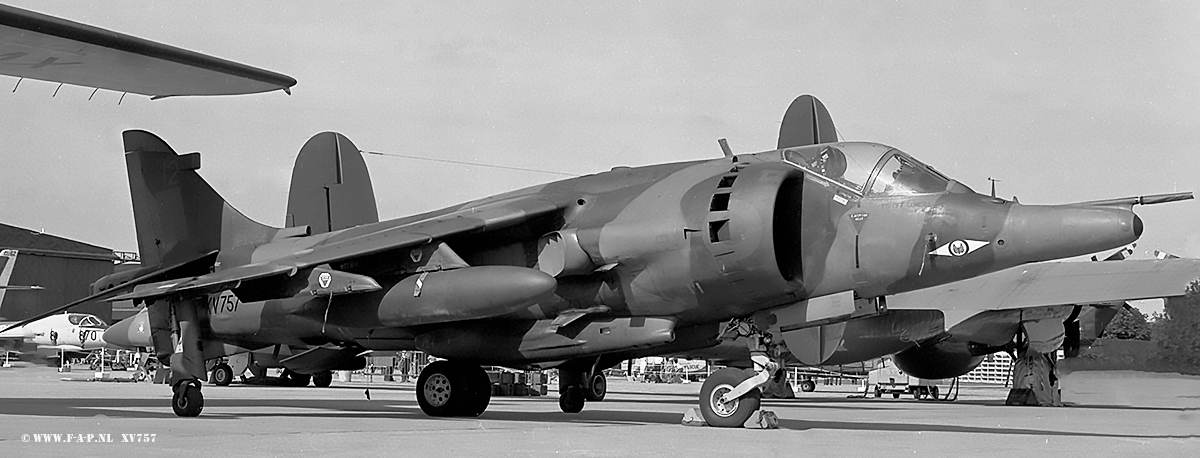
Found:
[888,259,1200,318]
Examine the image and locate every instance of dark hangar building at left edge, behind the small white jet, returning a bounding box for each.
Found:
[0,224,116,323]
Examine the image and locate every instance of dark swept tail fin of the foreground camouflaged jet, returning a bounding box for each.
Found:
[124,131,277,265]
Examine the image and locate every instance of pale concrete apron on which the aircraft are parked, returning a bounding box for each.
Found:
[0,366,1200,457]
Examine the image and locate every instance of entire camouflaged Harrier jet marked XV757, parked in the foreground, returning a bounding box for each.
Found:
[14,90,1195,426]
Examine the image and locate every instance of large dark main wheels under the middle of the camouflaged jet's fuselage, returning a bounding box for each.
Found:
[416,361,492,417]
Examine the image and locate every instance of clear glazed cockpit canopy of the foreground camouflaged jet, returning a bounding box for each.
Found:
[781,141,965,195]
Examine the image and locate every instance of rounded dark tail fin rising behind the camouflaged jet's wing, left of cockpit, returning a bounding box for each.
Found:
[287,132,379,234]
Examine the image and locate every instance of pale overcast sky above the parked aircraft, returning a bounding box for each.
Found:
[7,0,1200,272]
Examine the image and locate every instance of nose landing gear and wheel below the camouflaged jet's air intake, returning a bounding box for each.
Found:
[700,320,780,428]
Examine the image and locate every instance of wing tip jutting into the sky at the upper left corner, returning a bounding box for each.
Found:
[0,5,296,98]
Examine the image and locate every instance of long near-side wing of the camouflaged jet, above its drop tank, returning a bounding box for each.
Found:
[106,195,571,301]
